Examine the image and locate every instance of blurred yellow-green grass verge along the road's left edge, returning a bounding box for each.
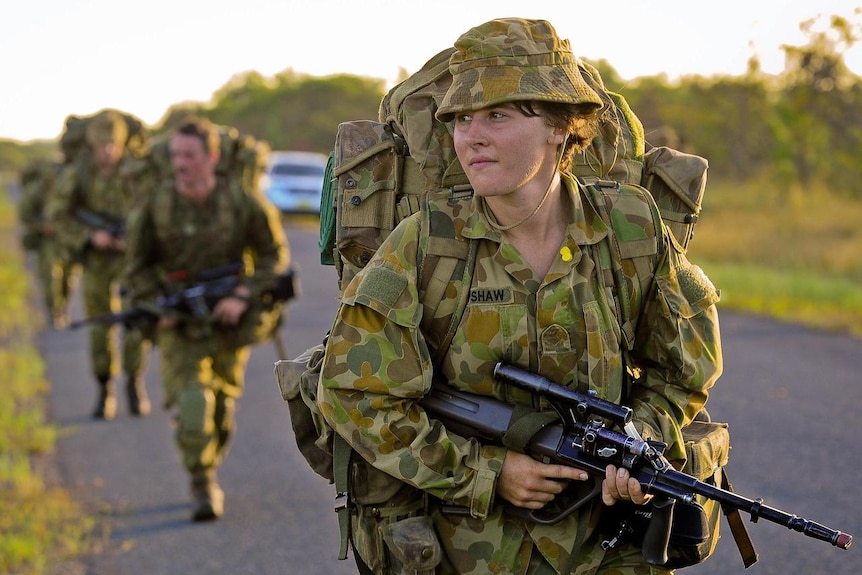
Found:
[0,188,94,575]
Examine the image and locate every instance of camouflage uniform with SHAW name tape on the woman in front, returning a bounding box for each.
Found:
[318,21,722,575]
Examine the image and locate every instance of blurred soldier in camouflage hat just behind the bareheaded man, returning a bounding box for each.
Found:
[47,110,150,419]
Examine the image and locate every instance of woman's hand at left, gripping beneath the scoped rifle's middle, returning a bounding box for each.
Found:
[497,450,589,509]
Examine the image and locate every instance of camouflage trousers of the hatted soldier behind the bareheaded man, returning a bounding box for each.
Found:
[81,252,150,379]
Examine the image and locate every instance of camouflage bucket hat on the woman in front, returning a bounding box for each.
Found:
[437,18,602,122]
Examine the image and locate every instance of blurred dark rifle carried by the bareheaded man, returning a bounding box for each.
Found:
[69,262,299,329]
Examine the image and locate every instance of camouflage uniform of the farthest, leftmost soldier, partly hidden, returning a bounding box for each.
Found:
[18,162,74,329]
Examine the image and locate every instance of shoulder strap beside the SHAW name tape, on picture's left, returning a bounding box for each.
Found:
[417,188,478,365]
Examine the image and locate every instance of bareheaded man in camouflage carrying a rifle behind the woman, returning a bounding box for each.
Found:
[127,120,290,521]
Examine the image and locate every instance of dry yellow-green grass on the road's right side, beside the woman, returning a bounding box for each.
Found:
[689,176,862,336]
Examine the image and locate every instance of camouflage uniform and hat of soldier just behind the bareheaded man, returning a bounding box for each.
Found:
[46,110,150,419]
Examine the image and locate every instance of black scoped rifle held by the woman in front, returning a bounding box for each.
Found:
[421,363,853,567]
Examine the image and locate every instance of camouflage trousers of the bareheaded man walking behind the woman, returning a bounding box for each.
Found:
[157,329,251,472]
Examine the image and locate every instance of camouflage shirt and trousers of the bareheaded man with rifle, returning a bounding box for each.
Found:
[127,168,290,514]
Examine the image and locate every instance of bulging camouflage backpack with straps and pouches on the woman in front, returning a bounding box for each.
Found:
[275,49,748,566]
